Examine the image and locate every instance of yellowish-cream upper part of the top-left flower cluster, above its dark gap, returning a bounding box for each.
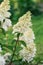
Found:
[0,0,11,19]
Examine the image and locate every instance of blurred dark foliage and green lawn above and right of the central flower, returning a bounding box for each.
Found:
[0,0,43,64]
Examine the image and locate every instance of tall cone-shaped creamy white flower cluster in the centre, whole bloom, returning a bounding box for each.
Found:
[13,11,36,62]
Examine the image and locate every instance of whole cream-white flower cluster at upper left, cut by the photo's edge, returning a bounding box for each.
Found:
[0,0,12,31]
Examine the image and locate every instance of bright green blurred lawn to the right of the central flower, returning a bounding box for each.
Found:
[32,15,43,59]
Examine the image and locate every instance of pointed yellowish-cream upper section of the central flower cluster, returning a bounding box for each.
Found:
[13,12,32,33]
